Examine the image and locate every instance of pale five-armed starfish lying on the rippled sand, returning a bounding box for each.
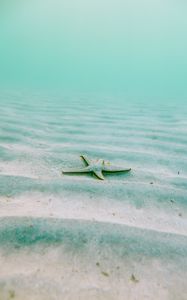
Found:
[62,155,131,180]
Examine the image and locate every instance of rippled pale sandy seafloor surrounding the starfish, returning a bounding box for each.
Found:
[0,93,187,300]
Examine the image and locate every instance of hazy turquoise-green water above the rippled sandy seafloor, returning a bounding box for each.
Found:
[0,0,187,101]
